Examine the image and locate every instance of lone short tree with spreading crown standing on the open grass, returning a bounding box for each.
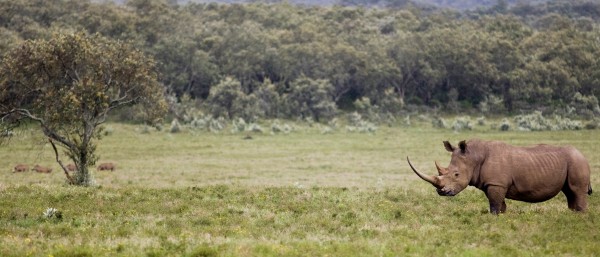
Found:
[0,33,166,186]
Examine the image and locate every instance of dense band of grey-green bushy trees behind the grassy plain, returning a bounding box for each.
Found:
[0,0,600,120]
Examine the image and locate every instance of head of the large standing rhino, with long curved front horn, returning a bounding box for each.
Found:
[406,141,476,196]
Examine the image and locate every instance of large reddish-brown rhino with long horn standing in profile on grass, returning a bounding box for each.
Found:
[406,139,592,214]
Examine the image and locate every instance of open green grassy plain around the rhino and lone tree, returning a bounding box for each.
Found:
[0,124,600,256]
